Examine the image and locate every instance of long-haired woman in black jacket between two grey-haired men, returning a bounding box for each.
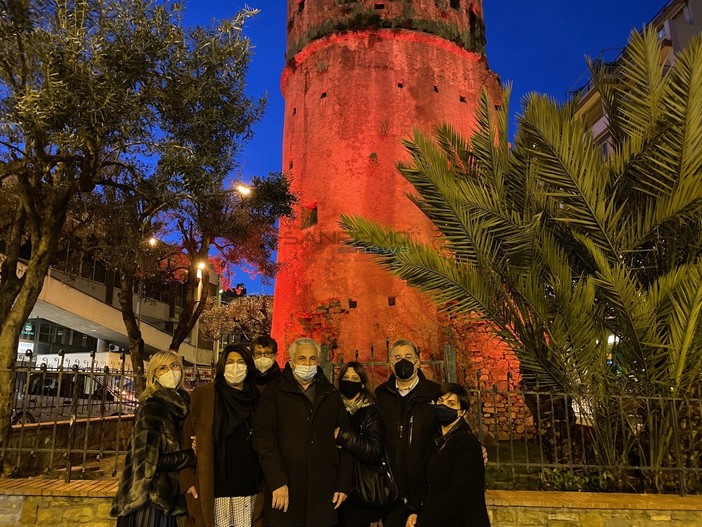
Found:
[334,362,385,527]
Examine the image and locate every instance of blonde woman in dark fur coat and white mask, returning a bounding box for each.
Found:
[111,351,195,527]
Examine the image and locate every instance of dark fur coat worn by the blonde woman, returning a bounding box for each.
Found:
[110,387,188,516]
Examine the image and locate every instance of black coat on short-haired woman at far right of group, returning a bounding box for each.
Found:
[417,421,490,527]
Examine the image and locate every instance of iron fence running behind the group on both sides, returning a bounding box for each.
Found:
[2,350,702,494]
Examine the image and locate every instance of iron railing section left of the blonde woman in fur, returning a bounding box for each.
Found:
[1,357,137,481]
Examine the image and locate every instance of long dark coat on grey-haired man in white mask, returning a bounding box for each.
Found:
[253,365,351,527]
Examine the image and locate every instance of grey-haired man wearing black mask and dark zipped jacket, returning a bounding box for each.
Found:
[375,340,440,527]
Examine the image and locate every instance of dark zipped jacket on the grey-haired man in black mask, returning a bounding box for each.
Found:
[375,371,440,510]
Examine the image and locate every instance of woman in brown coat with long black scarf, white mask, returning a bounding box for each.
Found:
[180,344,261,527]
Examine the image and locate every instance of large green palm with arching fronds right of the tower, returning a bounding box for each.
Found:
[341,29,702,488]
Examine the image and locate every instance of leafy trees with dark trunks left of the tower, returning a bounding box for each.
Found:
[0,0,293,412]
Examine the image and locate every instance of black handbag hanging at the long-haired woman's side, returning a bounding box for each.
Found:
[349,453,400,509]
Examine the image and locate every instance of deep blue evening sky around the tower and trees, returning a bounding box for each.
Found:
[185,0,667,294]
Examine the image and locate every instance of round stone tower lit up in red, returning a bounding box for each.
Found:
[273,0,500,360]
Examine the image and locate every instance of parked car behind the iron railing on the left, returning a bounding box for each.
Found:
[12,370,137,424]
